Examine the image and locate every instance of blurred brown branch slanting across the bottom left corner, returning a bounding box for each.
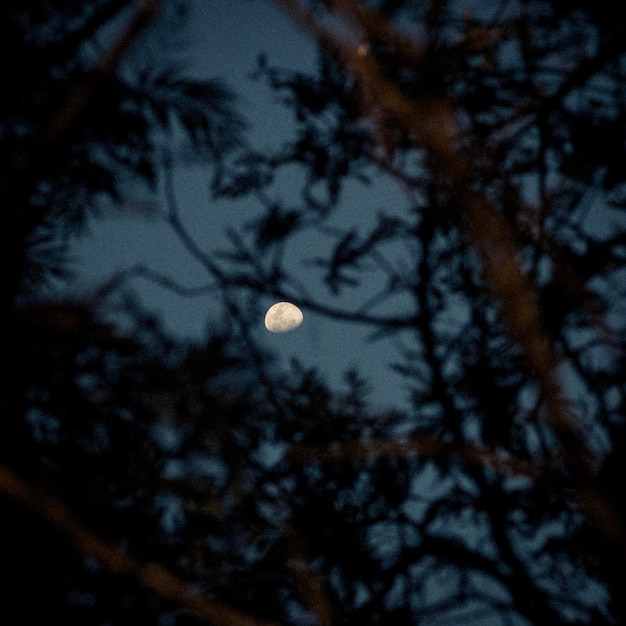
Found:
[0,465,275,626]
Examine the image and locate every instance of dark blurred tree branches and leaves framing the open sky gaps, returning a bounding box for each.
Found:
[0,0,626,625]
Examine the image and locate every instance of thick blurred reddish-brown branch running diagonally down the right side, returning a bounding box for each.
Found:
[276,0,626,556]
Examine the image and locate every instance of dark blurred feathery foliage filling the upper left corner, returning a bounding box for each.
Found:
[0,0,243,295]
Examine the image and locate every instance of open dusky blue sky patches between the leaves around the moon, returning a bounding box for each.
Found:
[68,0,412,406]
